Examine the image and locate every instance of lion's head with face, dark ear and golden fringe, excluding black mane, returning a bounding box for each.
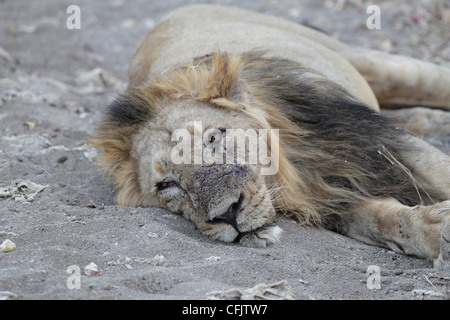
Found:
[93,54,296,247]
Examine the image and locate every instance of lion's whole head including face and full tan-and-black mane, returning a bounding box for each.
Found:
[93,52,418,247]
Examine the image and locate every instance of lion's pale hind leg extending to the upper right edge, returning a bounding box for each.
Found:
[339,48,450,110]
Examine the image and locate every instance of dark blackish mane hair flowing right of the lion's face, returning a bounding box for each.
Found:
[237,53,421,226]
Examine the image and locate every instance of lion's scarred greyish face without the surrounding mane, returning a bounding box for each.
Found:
[131,101,281,247]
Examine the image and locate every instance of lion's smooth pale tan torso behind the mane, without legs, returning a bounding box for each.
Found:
[129,6,378,110]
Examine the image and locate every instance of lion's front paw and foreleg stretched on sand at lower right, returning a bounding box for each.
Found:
[345,198,450,268]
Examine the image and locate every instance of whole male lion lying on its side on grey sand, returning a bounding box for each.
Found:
[93,5,450,267]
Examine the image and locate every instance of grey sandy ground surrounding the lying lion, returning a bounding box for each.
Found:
[0,0,450,299]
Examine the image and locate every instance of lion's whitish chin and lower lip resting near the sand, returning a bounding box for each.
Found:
[205,223,283,248]
